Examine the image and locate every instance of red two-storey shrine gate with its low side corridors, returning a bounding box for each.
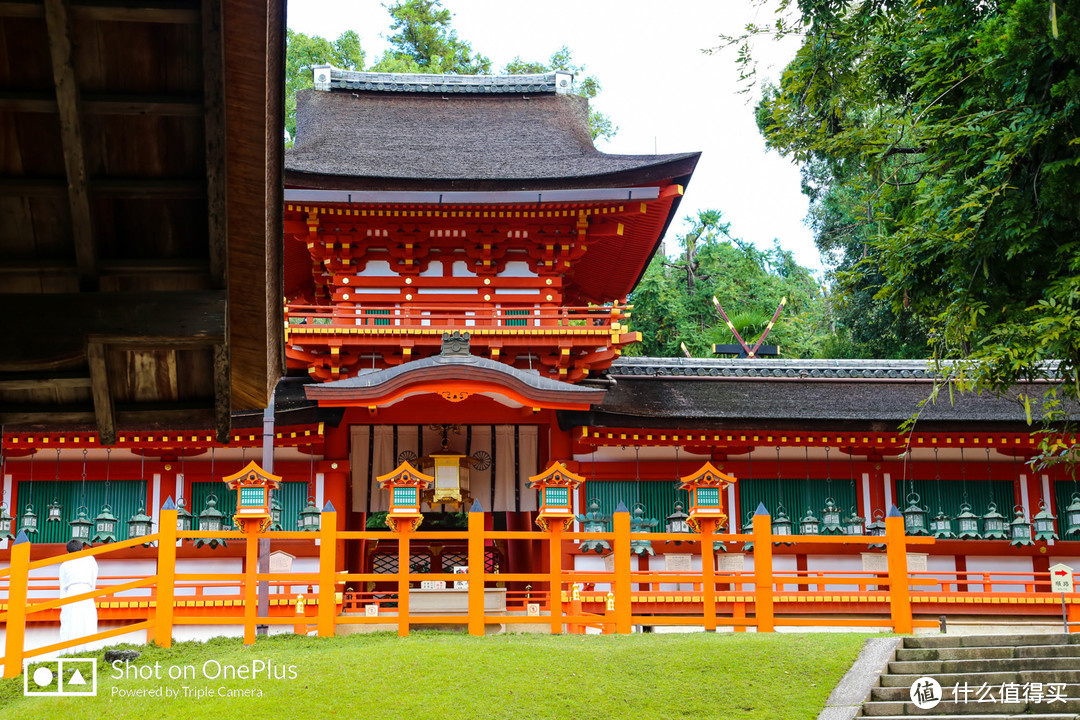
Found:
[0,67,1080,639]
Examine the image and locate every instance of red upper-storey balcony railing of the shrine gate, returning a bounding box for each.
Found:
[286,296,632,331]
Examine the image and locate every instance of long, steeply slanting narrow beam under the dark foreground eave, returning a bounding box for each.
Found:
[44,0,97,290]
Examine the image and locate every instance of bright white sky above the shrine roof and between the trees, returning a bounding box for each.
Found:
[288,0,821,269]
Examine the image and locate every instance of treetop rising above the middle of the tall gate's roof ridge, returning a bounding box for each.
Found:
[372,0,491,74]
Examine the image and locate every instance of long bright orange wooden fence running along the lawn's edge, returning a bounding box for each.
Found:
[0,508,1080,677]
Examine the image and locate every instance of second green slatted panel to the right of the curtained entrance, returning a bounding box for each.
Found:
[739,477,856,528]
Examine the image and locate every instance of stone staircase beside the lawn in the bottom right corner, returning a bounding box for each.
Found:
[858,634,1080,720]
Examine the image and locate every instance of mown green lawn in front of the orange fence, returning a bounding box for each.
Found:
[0,633,866,720]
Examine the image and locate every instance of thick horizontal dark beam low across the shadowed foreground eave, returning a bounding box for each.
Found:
[0,290,225,349]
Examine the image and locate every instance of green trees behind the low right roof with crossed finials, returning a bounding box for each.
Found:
[629,210,828,357]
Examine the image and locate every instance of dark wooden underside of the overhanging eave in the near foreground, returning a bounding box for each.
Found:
[0,0,284,444]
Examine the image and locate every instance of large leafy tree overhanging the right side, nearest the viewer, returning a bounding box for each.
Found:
[721,0,1080,451]
